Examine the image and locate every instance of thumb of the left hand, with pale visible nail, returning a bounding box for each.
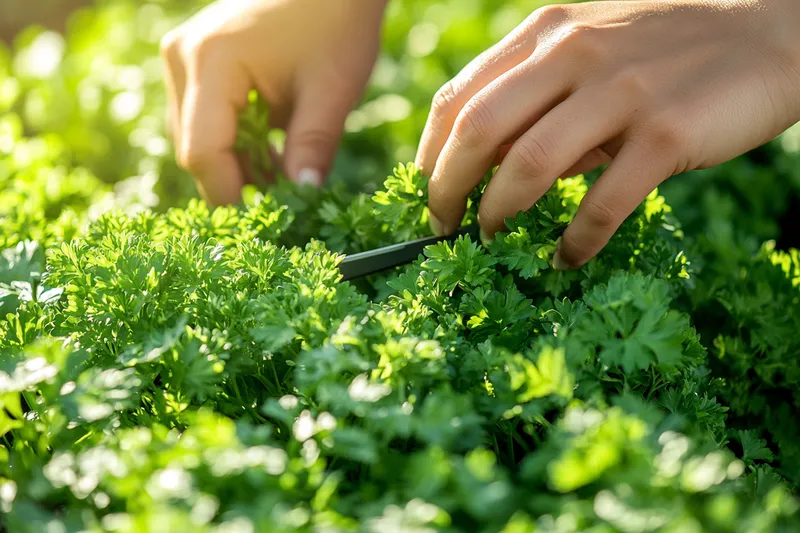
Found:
[284,83,355,186]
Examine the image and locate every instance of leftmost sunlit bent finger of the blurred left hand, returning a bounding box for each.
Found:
[179,44,249,205]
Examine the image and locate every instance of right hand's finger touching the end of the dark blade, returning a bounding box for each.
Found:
[428,55,573,234]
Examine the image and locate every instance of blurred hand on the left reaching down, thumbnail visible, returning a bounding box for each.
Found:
[161,0,387,205]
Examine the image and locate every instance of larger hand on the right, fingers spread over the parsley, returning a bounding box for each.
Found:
[417,0,800,269]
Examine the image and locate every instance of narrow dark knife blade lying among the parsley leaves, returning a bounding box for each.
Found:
[339,225,479,281]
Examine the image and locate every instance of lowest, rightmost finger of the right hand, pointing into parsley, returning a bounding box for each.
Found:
[553,143,675,270]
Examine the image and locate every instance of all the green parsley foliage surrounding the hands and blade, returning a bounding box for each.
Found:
[0,0,800,533]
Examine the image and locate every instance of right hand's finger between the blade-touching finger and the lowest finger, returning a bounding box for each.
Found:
[479,87,628,239]
